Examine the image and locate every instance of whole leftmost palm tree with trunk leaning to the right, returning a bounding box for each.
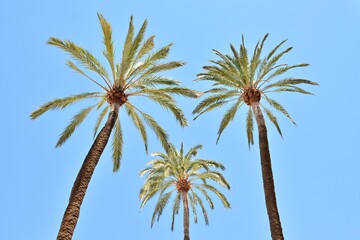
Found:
[31,14,198,239]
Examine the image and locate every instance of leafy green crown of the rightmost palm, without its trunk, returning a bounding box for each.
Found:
[193,34,318,146]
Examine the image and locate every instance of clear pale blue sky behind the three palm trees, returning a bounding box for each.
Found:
[0,0,360,240]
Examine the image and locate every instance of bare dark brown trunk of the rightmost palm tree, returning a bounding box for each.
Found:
[251,102,284,240]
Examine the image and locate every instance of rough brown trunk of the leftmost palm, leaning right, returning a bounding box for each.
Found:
[57,104,120,240]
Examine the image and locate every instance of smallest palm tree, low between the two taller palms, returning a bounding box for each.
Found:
[140,144,230,240]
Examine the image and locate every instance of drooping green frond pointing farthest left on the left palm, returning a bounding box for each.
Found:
[30,92,101,120]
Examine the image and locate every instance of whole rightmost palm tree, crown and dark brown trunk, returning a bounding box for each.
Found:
[193,34,318,239]
